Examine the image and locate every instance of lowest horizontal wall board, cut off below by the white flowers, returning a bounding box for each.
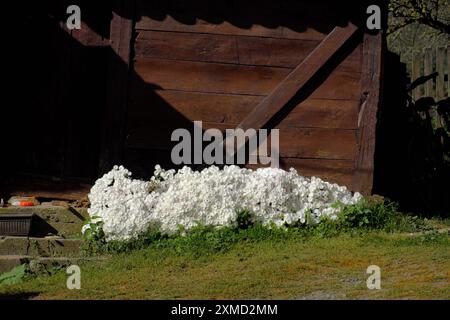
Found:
[246,158,353,190]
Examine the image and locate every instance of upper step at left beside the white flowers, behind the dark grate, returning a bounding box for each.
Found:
[0,205,89,238]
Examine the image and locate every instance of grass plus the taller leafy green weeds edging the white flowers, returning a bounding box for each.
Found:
[0,203,450,299]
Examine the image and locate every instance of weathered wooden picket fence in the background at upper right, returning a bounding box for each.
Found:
[410,46,450,101]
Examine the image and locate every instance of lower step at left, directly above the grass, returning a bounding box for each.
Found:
[0,237,82,257]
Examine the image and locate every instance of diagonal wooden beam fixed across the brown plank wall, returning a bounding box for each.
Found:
[237,23,358,130]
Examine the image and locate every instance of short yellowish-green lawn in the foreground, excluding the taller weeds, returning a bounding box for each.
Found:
[0,231,450,299]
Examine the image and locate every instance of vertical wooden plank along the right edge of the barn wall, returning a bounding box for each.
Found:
[353,31,384,195]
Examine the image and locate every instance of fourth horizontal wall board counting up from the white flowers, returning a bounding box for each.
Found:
[131,59,361,100]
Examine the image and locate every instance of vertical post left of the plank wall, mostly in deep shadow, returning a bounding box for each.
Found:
[99,0,135,174]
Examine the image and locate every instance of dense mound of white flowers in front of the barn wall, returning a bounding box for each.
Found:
[89,166,361,240]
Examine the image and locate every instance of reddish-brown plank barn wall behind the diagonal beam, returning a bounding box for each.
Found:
[125,1,370,187]
